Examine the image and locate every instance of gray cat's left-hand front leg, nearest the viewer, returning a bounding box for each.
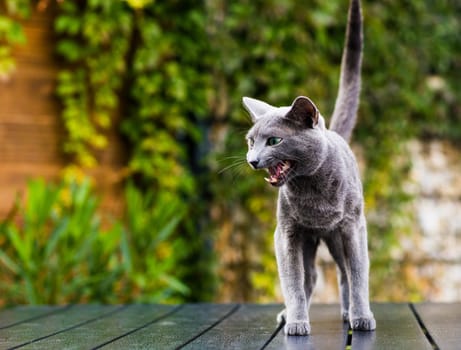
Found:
[275,228,310,335]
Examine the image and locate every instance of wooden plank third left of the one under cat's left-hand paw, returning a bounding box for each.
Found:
[17,305,178,350]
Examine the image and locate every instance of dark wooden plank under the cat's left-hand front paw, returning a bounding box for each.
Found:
[266,304,346,350]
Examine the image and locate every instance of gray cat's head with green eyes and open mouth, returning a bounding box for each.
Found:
[243,96,327,187]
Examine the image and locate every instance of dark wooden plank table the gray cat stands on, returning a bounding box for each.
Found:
[0,303,461,350]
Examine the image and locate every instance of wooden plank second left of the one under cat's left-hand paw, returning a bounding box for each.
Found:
[96,304,237,350]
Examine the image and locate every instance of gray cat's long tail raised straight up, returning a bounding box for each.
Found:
[329,0,363,141]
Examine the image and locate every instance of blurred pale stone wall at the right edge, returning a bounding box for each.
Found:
[406,141,461,301]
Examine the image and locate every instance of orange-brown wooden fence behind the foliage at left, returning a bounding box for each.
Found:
[0,4,126,218]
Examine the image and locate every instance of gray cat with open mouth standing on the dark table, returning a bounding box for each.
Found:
[243,0,376,335]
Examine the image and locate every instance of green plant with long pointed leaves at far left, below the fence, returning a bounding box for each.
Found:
[0,180,122,304]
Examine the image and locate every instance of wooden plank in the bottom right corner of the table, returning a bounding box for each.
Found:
[414,303,461,350]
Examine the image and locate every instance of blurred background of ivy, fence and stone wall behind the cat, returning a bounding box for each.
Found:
[0,0,461,305]
